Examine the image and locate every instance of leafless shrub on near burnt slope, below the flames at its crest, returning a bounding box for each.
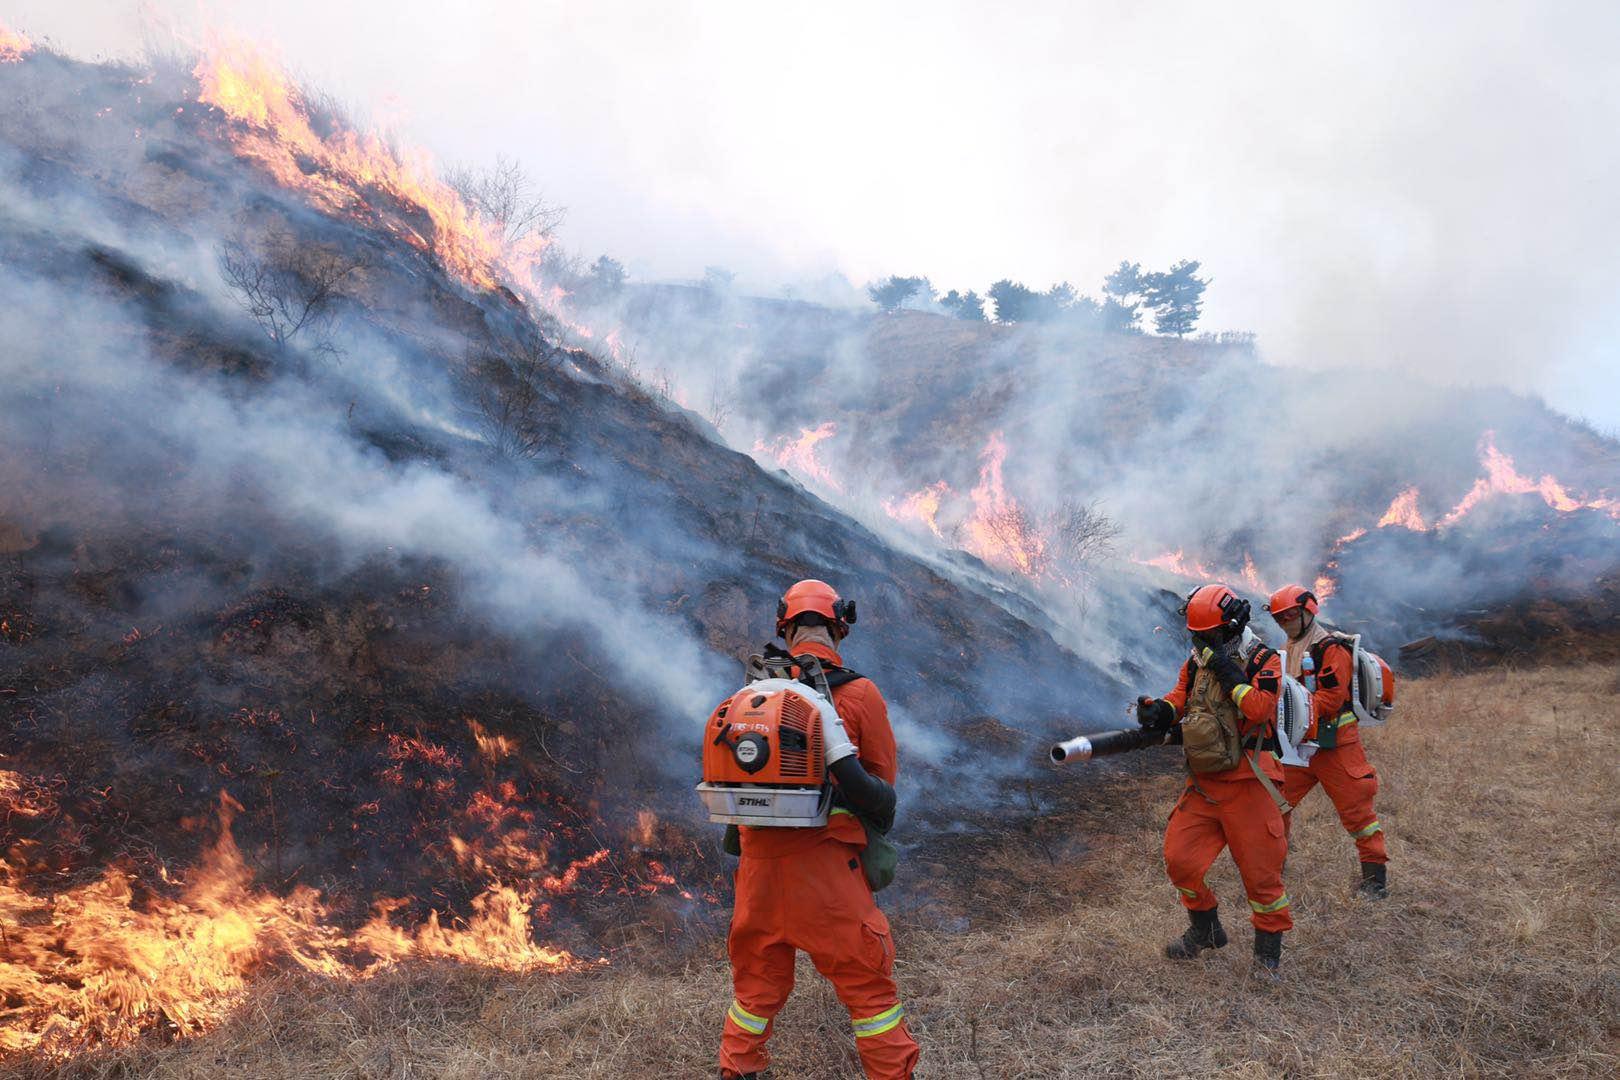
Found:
[219,236,365,353]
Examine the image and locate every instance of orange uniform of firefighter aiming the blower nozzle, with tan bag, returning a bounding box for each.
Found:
[1165,649,1294,931]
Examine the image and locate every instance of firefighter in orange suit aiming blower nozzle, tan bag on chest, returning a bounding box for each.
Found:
[1137,585,1294,975]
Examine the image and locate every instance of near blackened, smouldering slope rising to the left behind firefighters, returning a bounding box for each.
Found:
[0,52,1113,952]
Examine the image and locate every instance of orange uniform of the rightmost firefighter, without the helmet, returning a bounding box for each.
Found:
[1283,620,1390,863]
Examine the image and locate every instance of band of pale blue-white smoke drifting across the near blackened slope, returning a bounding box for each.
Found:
[0,195,727,735]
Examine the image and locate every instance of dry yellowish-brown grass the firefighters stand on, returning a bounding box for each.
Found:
[15,665,1620,1080]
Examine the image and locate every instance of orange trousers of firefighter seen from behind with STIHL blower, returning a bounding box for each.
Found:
[719,839,920,1080]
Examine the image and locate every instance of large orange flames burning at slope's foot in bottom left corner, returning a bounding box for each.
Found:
[0,795,580,1054]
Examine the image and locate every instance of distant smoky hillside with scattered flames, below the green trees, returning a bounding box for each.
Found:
[616,287,1620,648]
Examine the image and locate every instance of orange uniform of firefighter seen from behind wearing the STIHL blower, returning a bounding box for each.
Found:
[719,641,920,1080]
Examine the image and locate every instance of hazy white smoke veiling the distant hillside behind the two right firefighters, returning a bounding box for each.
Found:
[560,275,1615,676]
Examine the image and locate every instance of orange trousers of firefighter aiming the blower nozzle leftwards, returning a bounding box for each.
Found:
[1165,777,1294,931]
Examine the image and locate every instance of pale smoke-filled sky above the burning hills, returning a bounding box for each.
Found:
[12,0,1620,431]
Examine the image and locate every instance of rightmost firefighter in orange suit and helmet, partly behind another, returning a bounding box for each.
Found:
[1267,585,1390,899]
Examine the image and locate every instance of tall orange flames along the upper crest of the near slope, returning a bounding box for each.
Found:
[193,40,524,288]
